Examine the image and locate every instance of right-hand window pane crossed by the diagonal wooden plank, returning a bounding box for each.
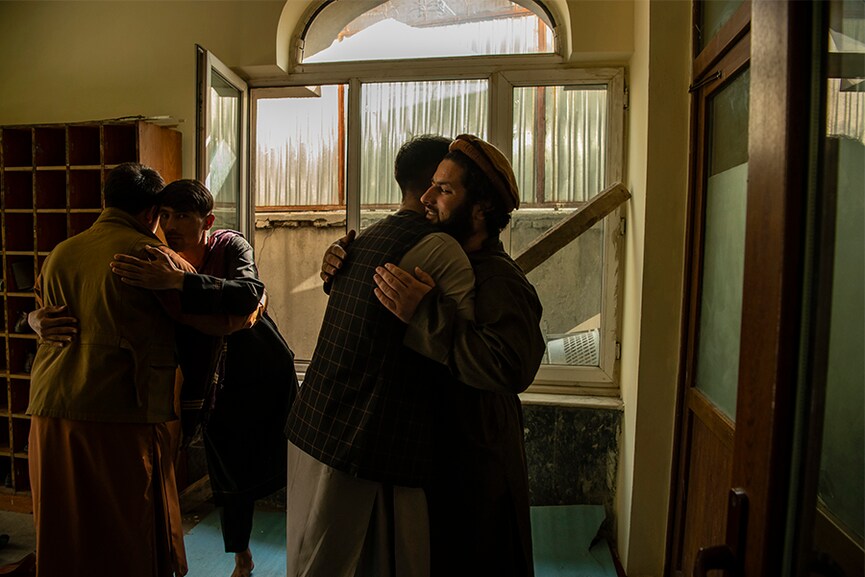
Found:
[510,85,607,366]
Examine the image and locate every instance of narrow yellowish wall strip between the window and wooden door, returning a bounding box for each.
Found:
[617,0,691,577]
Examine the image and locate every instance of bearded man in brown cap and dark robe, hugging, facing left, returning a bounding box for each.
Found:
[375,134,545,577]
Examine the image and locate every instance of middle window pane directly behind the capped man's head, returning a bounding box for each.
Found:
[360,80,489,229]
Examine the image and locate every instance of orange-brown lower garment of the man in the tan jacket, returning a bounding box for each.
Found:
[29,416,187,577]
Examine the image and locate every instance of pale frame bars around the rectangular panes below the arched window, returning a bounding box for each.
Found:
[250,9,627,397]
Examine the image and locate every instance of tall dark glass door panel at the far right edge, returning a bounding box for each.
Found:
[818,1,865,552]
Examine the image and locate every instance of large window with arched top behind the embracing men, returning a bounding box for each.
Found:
[252,0,624,395]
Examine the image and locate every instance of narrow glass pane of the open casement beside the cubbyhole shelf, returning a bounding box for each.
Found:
[212,69,243,230]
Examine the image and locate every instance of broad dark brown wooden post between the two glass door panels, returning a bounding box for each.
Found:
[731,0,823,577]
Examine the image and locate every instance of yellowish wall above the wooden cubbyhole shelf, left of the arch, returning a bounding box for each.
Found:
[0,0,285,178]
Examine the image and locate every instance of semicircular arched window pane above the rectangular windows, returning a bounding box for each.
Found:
[300,0,554,64]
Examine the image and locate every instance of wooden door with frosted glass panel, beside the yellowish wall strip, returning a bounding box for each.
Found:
[667,2,751,576]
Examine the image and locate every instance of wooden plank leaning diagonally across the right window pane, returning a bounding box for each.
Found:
[514,182,631,274]
